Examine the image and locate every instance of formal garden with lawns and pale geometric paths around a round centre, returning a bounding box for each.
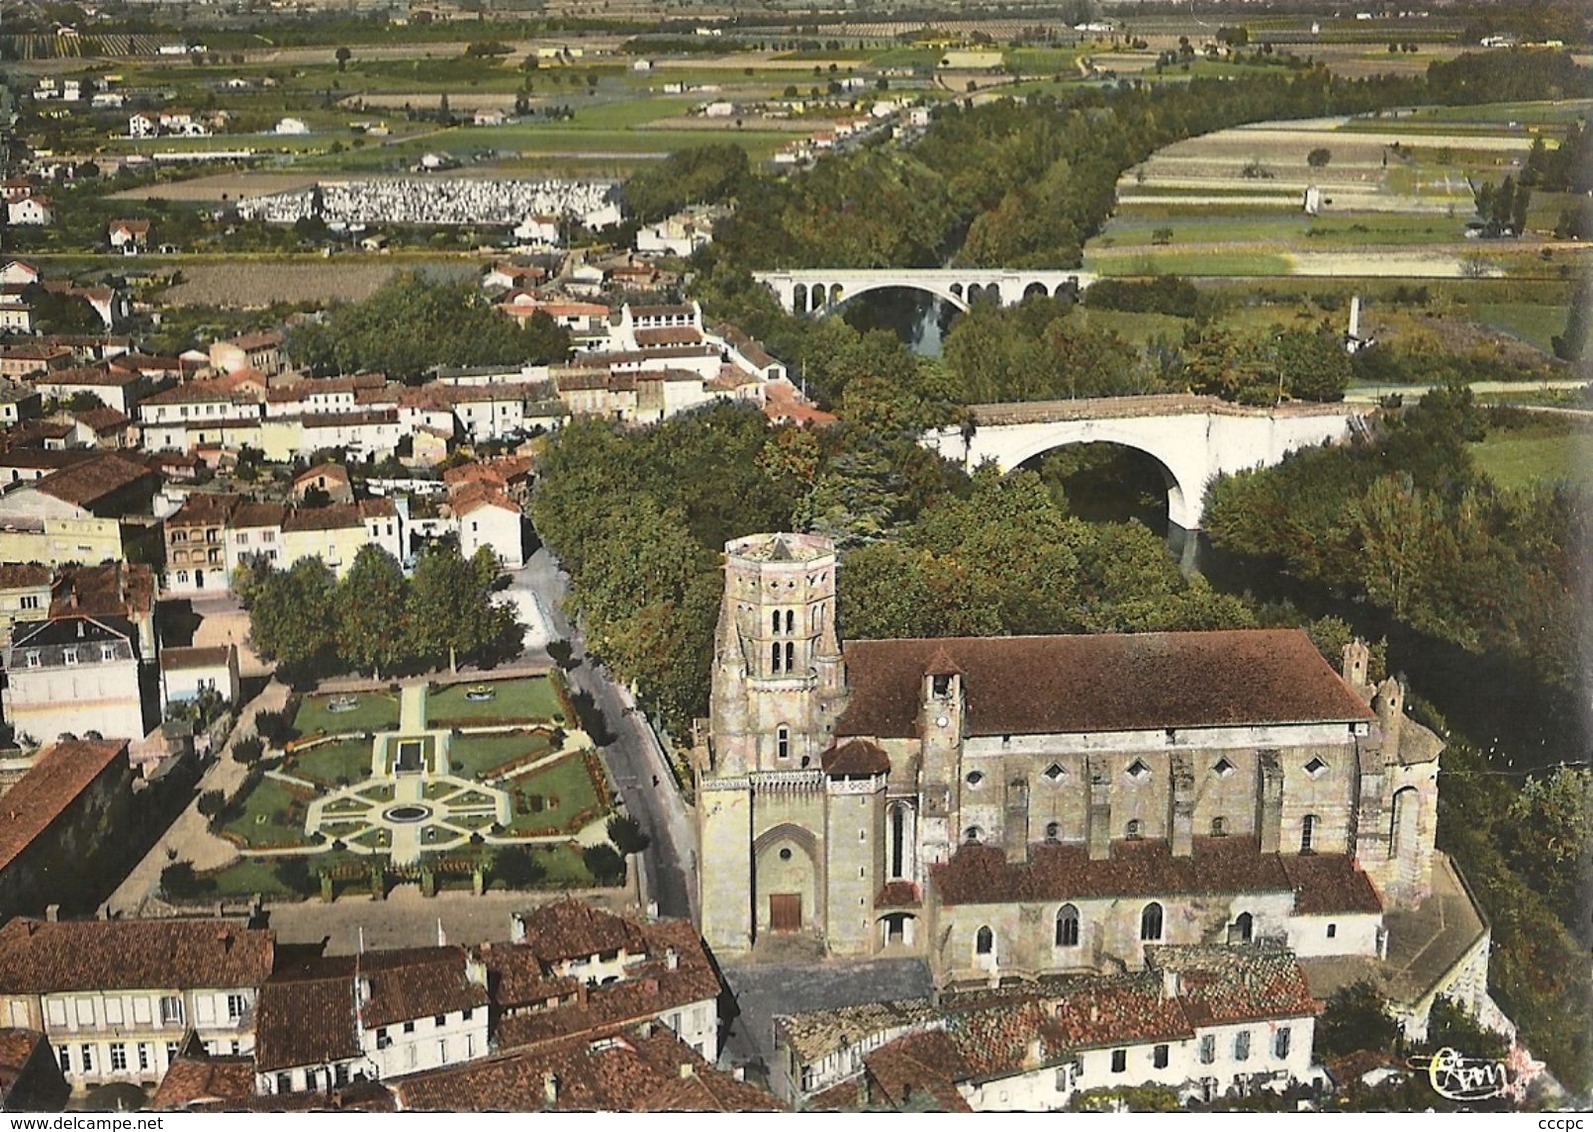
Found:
[172,672,645,901]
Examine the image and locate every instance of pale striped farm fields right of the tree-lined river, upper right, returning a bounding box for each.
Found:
[1085,100,1593,305]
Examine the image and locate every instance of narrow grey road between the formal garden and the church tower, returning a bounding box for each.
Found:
[516,546,696,920]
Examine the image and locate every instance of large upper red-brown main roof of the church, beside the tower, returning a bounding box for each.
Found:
[836,629,1373,739]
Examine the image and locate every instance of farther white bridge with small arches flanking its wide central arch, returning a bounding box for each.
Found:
[753,267,1094,314]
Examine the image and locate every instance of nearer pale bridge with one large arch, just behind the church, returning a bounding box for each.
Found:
[924,393,1365,530]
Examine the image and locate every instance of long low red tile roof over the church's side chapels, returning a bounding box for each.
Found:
[930,837,1380,912]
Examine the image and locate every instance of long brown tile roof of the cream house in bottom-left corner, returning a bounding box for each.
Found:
[0,910,274,995]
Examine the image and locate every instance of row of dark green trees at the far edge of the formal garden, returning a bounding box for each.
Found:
[234,543,524,683]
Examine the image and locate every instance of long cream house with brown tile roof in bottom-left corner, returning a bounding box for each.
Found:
[0,917,276,1092]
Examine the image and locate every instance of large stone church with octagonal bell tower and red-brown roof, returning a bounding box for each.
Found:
[695,533,1446,986]
